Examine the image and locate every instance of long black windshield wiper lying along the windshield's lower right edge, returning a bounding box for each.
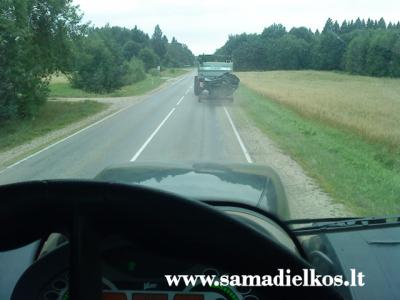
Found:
[285,215,400,236]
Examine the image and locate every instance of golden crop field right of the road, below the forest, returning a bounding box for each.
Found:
[237,71,400,147]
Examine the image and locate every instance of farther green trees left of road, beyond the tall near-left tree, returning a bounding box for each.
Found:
[69,25,194,93]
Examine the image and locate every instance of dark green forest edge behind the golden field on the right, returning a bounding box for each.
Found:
[216,18,400,77]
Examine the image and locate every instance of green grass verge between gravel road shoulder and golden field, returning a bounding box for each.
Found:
[236,85,400,215]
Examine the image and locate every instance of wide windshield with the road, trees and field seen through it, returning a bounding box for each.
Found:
[0,0,400,220]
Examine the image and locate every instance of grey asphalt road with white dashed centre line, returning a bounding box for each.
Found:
[0,74,251,184]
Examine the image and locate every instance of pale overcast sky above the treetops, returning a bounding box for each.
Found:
[73,0,400,55]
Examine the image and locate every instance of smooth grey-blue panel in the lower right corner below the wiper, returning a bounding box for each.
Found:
[304,227,400,300]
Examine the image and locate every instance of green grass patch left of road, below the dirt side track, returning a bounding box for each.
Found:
[0,101,108,151]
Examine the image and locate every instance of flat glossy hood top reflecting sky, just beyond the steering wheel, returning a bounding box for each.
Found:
[97,165,268,206]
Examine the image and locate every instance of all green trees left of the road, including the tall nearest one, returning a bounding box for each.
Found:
[0,0,194,122]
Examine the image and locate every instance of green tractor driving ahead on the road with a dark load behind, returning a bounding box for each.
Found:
[194,55,240,101]
